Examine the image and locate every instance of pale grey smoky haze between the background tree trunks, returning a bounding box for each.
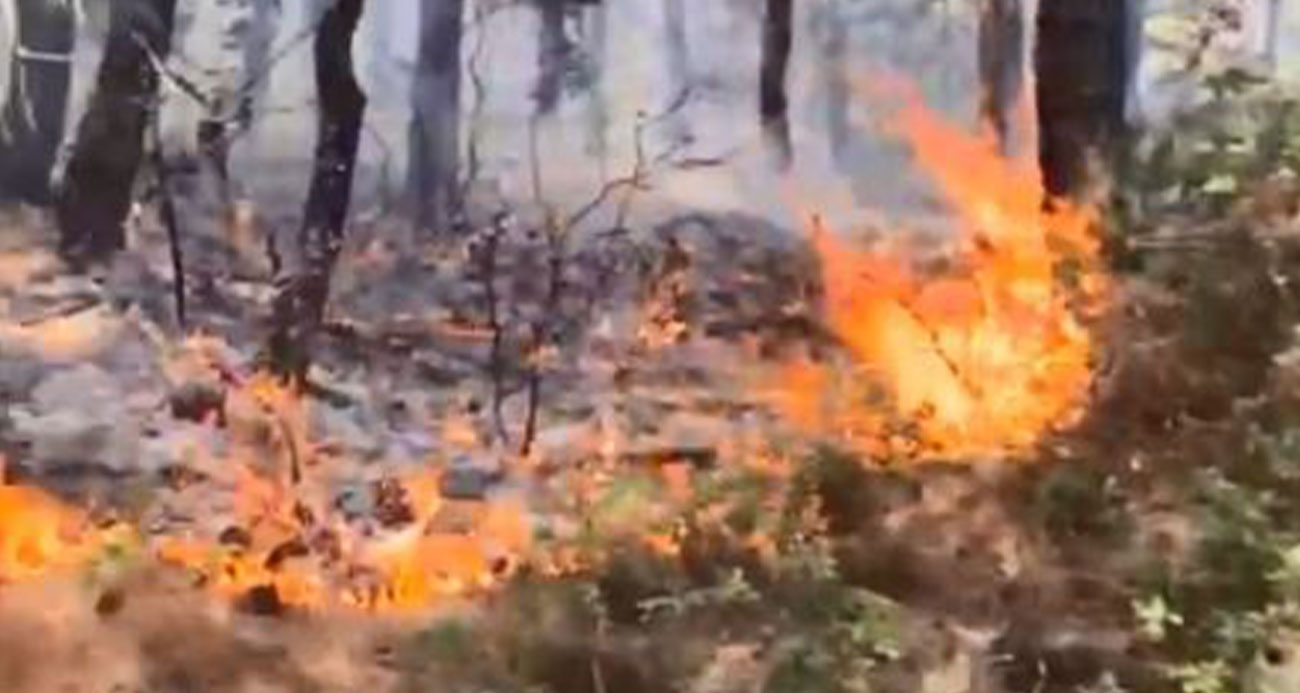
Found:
[0,0,1300,235]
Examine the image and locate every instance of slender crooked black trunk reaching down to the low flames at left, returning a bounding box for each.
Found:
[269,0,365,385]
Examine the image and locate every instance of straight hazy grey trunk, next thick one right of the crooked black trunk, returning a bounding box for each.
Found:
[407,0,465,230]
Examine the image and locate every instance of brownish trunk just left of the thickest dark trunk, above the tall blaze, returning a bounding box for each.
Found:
[978,0,1024,151]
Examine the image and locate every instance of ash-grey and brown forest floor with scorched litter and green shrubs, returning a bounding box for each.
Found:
[0,176,1300,693]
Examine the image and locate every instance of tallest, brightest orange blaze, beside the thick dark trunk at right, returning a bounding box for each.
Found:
[783,94,1105,456]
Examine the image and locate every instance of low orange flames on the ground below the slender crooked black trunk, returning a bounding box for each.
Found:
[138,376,548,615]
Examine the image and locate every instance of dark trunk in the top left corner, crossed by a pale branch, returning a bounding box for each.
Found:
[0,0,75,205]
